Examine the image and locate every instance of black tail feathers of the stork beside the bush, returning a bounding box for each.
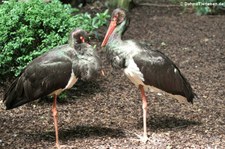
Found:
[3,78,28,110]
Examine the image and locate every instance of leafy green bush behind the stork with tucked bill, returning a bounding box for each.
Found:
[0,0,109,80]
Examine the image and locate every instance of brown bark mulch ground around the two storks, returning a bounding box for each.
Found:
[0,1,225,149]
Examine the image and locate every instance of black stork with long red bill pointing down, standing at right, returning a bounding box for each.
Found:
[101,8,195,143]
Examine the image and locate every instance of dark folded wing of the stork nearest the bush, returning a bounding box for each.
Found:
[4,44,76,109]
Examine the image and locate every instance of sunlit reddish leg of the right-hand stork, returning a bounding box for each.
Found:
[139,85,148,142]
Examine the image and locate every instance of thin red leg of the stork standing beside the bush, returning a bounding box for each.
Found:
[52,95,59,148]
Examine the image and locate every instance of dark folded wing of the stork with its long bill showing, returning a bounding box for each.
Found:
[133,46,194,102]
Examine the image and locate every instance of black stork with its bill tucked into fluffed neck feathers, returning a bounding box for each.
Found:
[4,29,101,148]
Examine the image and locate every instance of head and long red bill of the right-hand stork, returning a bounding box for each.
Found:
[101,8,129,47]
